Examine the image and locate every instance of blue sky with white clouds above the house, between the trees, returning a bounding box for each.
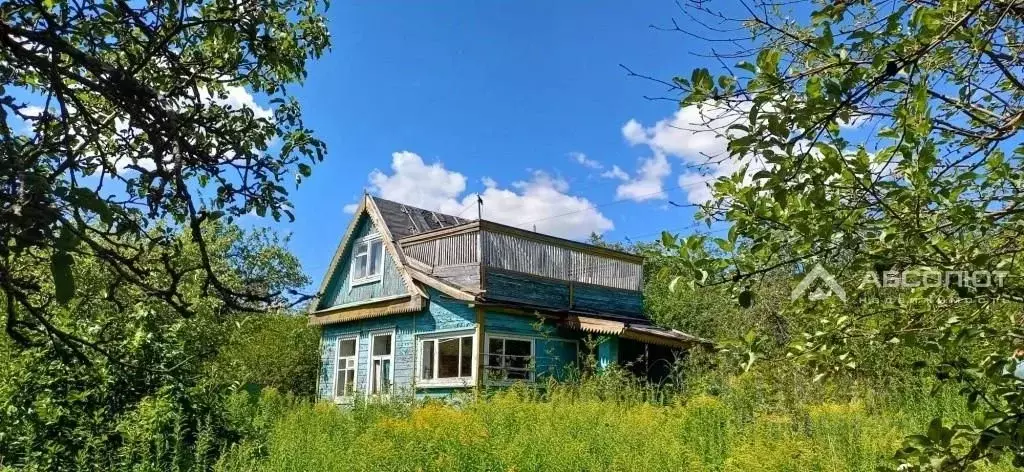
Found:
[250,1,737,280]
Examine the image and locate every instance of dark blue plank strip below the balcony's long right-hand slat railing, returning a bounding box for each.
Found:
[486,270,644,317]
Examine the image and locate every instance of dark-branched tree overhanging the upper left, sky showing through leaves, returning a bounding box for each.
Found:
[0,0,329,360]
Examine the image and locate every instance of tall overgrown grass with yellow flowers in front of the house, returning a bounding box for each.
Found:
[211,370,1009,471]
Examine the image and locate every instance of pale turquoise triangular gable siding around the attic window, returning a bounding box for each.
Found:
[316,215,409,309]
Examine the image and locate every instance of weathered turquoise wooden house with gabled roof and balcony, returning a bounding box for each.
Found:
[309,196,701,401]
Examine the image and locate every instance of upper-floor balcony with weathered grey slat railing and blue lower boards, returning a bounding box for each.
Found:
[398,221,643,317]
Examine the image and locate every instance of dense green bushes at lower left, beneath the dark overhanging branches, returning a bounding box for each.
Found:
[0,223,307,470]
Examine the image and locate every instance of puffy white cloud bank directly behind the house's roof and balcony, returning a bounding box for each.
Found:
[370,151,614,239]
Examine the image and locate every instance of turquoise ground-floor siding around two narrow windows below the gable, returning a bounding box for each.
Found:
[318,290,476,398]
